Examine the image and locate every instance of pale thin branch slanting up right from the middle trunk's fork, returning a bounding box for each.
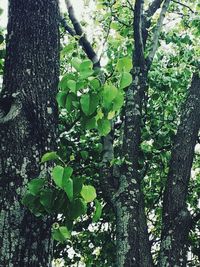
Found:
[147,0,170,68]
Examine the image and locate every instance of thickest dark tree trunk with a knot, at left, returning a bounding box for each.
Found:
[0,0,59,267]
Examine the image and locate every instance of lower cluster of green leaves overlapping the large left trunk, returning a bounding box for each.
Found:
[22,152,102,242]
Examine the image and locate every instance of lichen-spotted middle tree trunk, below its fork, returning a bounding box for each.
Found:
[113,68,153,267]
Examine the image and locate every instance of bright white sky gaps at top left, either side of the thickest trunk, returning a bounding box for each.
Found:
[0,0,83,27]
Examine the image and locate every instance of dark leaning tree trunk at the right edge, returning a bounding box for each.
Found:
[159,75,200,267]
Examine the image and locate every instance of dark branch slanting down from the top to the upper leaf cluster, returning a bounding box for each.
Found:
[65,0,100,68]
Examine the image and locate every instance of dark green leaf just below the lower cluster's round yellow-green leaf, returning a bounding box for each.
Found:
[70,198,87,219]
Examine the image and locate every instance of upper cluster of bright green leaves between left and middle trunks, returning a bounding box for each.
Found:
[57,58,132,136]
